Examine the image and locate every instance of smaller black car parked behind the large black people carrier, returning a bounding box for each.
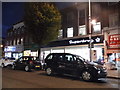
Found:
[12,56,41,72]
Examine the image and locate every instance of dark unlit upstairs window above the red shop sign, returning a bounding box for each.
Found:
[109,13,119,27]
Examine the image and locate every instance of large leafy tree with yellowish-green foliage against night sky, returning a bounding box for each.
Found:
[24,2,61,46]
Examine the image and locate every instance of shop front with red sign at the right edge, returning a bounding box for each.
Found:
[106,34,120,67]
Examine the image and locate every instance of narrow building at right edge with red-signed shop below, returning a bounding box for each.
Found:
[103,2,120,66]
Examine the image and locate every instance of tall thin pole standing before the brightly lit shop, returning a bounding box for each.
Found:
[89,0,92,61]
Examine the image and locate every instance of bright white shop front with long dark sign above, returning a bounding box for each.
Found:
[40,36,104,61]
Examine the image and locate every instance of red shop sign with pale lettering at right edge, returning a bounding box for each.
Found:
[108,34,120,48]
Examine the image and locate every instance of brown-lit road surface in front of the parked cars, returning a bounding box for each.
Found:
[2,68,119,88]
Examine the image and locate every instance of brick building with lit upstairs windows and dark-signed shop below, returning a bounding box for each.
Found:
[41,2,120,66]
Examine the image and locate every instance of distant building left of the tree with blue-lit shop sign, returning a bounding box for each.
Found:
[4,21,38,59]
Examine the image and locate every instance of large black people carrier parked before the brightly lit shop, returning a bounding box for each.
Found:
[45,53,107,81]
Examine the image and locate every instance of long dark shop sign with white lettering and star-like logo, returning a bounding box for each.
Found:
[45,35,104,47]
